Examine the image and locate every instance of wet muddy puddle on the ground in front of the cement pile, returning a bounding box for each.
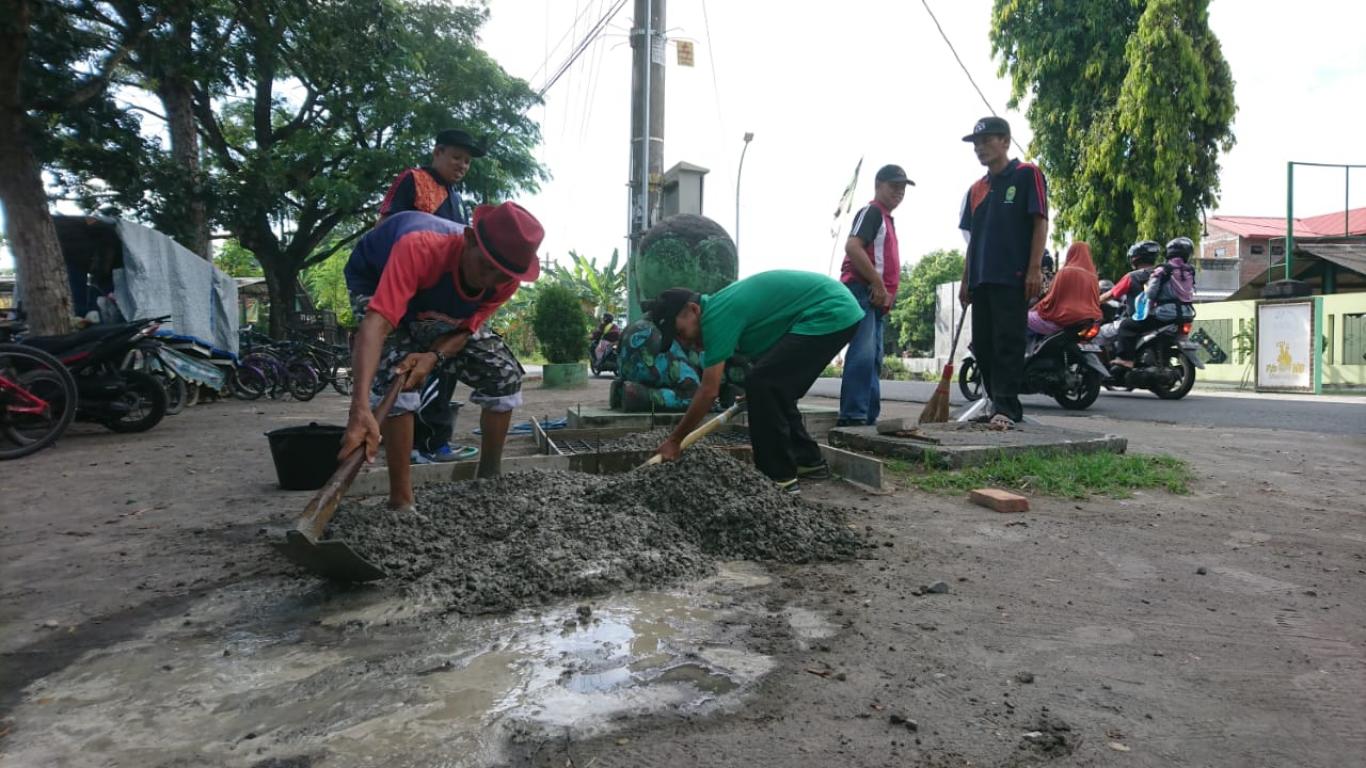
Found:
[0,562,833,767]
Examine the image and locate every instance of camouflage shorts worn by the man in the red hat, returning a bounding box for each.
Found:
[351,295,526,415]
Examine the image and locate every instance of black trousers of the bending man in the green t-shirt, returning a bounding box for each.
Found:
[744,323,858,481]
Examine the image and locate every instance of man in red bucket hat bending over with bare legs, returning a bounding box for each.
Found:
[340,202,545,510]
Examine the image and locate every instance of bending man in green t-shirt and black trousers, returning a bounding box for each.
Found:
[645,269,863,493]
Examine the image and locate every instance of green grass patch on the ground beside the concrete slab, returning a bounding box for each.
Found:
[887,451,1193,499]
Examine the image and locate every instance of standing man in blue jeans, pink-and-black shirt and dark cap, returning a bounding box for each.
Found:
[839,165,915,426]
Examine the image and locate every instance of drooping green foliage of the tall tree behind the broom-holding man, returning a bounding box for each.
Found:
[990,0,1235,276]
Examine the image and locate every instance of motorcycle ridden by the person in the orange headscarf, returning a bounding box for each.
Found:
[958,324,1109,410]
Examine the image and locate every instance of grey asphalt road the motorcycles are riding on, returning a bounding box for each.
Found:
[810,379,1366,435]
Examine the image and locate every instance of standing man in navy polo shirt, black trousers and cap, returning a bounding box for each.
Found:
[958,118,1048,429]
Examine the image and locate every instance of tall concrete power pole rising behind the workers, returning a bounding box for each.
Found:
[626,0,665,323]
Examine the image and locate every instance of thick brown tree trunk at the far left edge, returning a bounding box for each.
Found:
[0,3,72,335]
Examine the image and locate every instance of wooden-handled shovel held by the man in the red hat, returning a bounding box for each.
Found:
[275,376,404,581]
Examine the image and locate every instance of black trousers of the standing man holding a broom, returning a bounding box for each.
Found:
[973,286,1029,421]
